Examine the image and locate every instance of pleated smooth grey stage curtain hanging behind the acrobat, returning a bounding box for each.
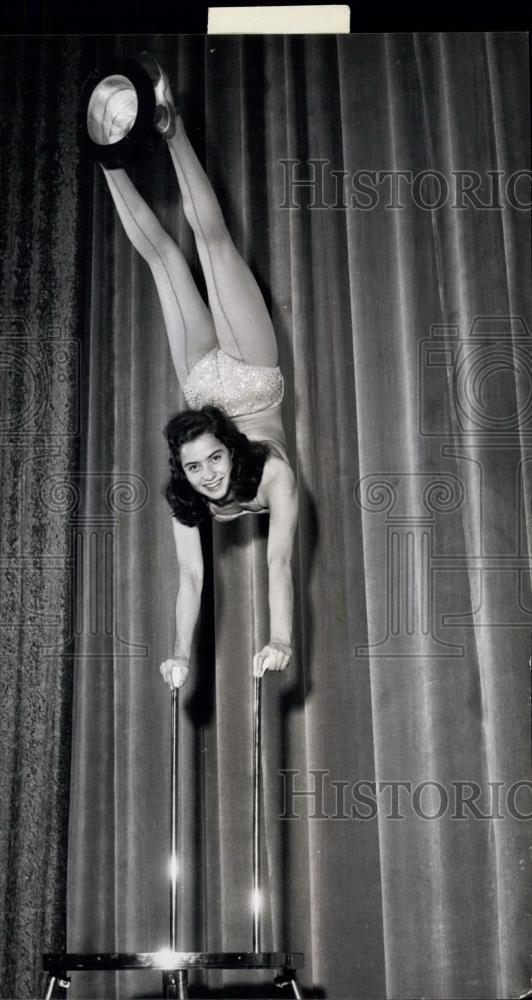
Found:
[2,27,532,998]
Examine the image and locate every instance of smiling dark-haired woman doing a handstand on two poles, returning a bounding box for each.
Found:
[87,53,297,687]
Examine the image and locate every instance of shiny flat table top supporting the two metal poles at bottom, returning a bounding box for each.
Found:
[42,948,305,978]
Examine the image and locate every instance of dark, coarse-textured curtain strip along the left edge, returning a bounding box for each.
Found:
[0,38,92,997]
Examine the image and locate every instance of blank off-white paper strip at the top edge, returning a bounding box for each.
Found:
[207,4,350,35]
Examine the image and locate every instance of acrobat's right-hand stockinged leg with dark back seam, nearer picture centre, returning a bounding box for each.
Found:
[167,115,277,366]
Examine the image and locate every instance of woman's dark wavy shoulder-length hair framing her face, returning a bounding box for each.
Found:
[163,406,270,527]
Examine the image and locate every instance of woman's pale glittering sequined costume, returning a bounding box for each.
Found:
[183,347,288,521]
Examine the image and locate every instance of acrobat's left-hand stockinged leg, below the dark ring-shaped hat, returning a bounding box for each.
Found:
[102,167,217,386]
